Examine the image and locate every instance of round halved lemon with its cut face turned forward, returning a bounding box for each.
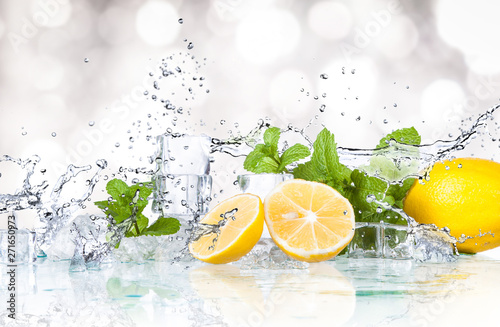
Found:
[264,179,354,262]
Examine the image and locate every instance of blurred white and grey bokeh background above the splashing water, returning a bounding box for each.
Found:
[0,0,500,241]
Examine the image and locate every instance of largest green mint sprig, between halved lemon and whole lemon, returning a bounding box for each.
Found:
[293,127,420,223]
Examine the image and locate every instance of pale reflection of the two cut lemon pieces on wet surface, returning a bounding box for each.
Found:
[189,263,356,326]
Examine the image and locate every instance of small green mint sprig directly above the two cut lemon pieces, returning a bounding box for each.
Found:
[243,127,311,174]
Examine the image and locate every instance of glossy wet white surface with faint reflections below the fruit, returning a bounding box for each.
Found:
[1,255,500,326]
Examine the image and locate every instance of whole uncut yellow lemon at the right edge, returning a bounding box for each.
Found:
[403,158,500,253]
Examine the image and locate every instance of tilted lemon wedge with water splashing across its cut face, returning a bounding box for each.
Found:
[189,193,264,264]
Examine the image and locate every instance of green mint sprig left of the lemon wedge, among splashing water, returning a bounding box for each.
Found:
[94,178,180,242]
